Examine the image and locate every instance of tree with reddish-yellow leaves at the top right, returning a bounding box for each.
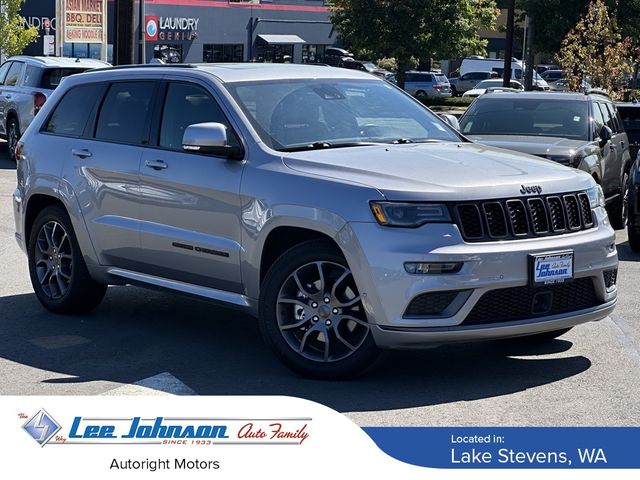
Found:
[558,0,632,94]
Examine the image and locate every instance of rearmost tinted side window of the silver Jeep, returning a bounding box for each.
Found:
[44,83,102,137]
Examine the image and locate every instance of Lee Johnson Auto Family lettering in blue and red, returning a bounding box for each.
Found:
[48,417,311,446]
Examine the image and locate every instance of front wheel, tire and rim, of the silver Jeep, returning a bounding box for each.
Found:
[260,240,381,379]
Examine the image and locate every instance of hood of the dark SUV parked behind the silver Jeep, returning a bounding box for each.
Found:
[467,135,589,157]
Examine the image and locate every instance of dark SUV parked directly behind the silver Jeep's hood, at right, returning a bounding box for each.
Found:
[460,92,632,230]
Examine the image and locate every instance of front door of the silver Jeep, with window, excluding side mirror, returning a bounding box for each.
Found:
[140,77,244,293]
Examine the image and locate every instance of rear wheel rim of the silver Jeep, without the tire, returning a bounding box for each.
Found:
[34,220,73,300]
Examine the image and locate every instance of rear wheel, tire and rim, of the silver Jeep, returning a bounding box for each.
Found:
[27,206,107,313]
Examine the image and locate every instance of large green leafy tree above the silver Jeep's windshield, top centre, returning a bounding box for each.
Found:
[331,0,499,86]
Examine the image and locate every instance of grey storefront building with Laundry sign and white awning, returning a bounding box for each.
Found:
[22,0,337,63]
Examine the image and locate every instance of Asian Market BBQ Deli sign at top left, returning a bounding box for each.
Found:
[61,0,107,43]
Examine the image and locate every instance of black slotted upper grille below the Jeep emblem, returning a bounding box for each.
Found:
[453,192,595,242]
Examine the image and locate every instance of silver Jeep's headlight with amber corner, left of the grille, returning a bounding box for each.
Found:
[370,202,451,228]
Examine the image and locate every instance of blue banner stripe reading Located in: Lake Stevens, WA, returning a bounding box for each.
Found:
[363,427,640,468]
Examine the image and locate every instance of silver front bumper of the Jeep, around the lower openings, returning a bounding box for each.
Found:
[338,208,618,347]
